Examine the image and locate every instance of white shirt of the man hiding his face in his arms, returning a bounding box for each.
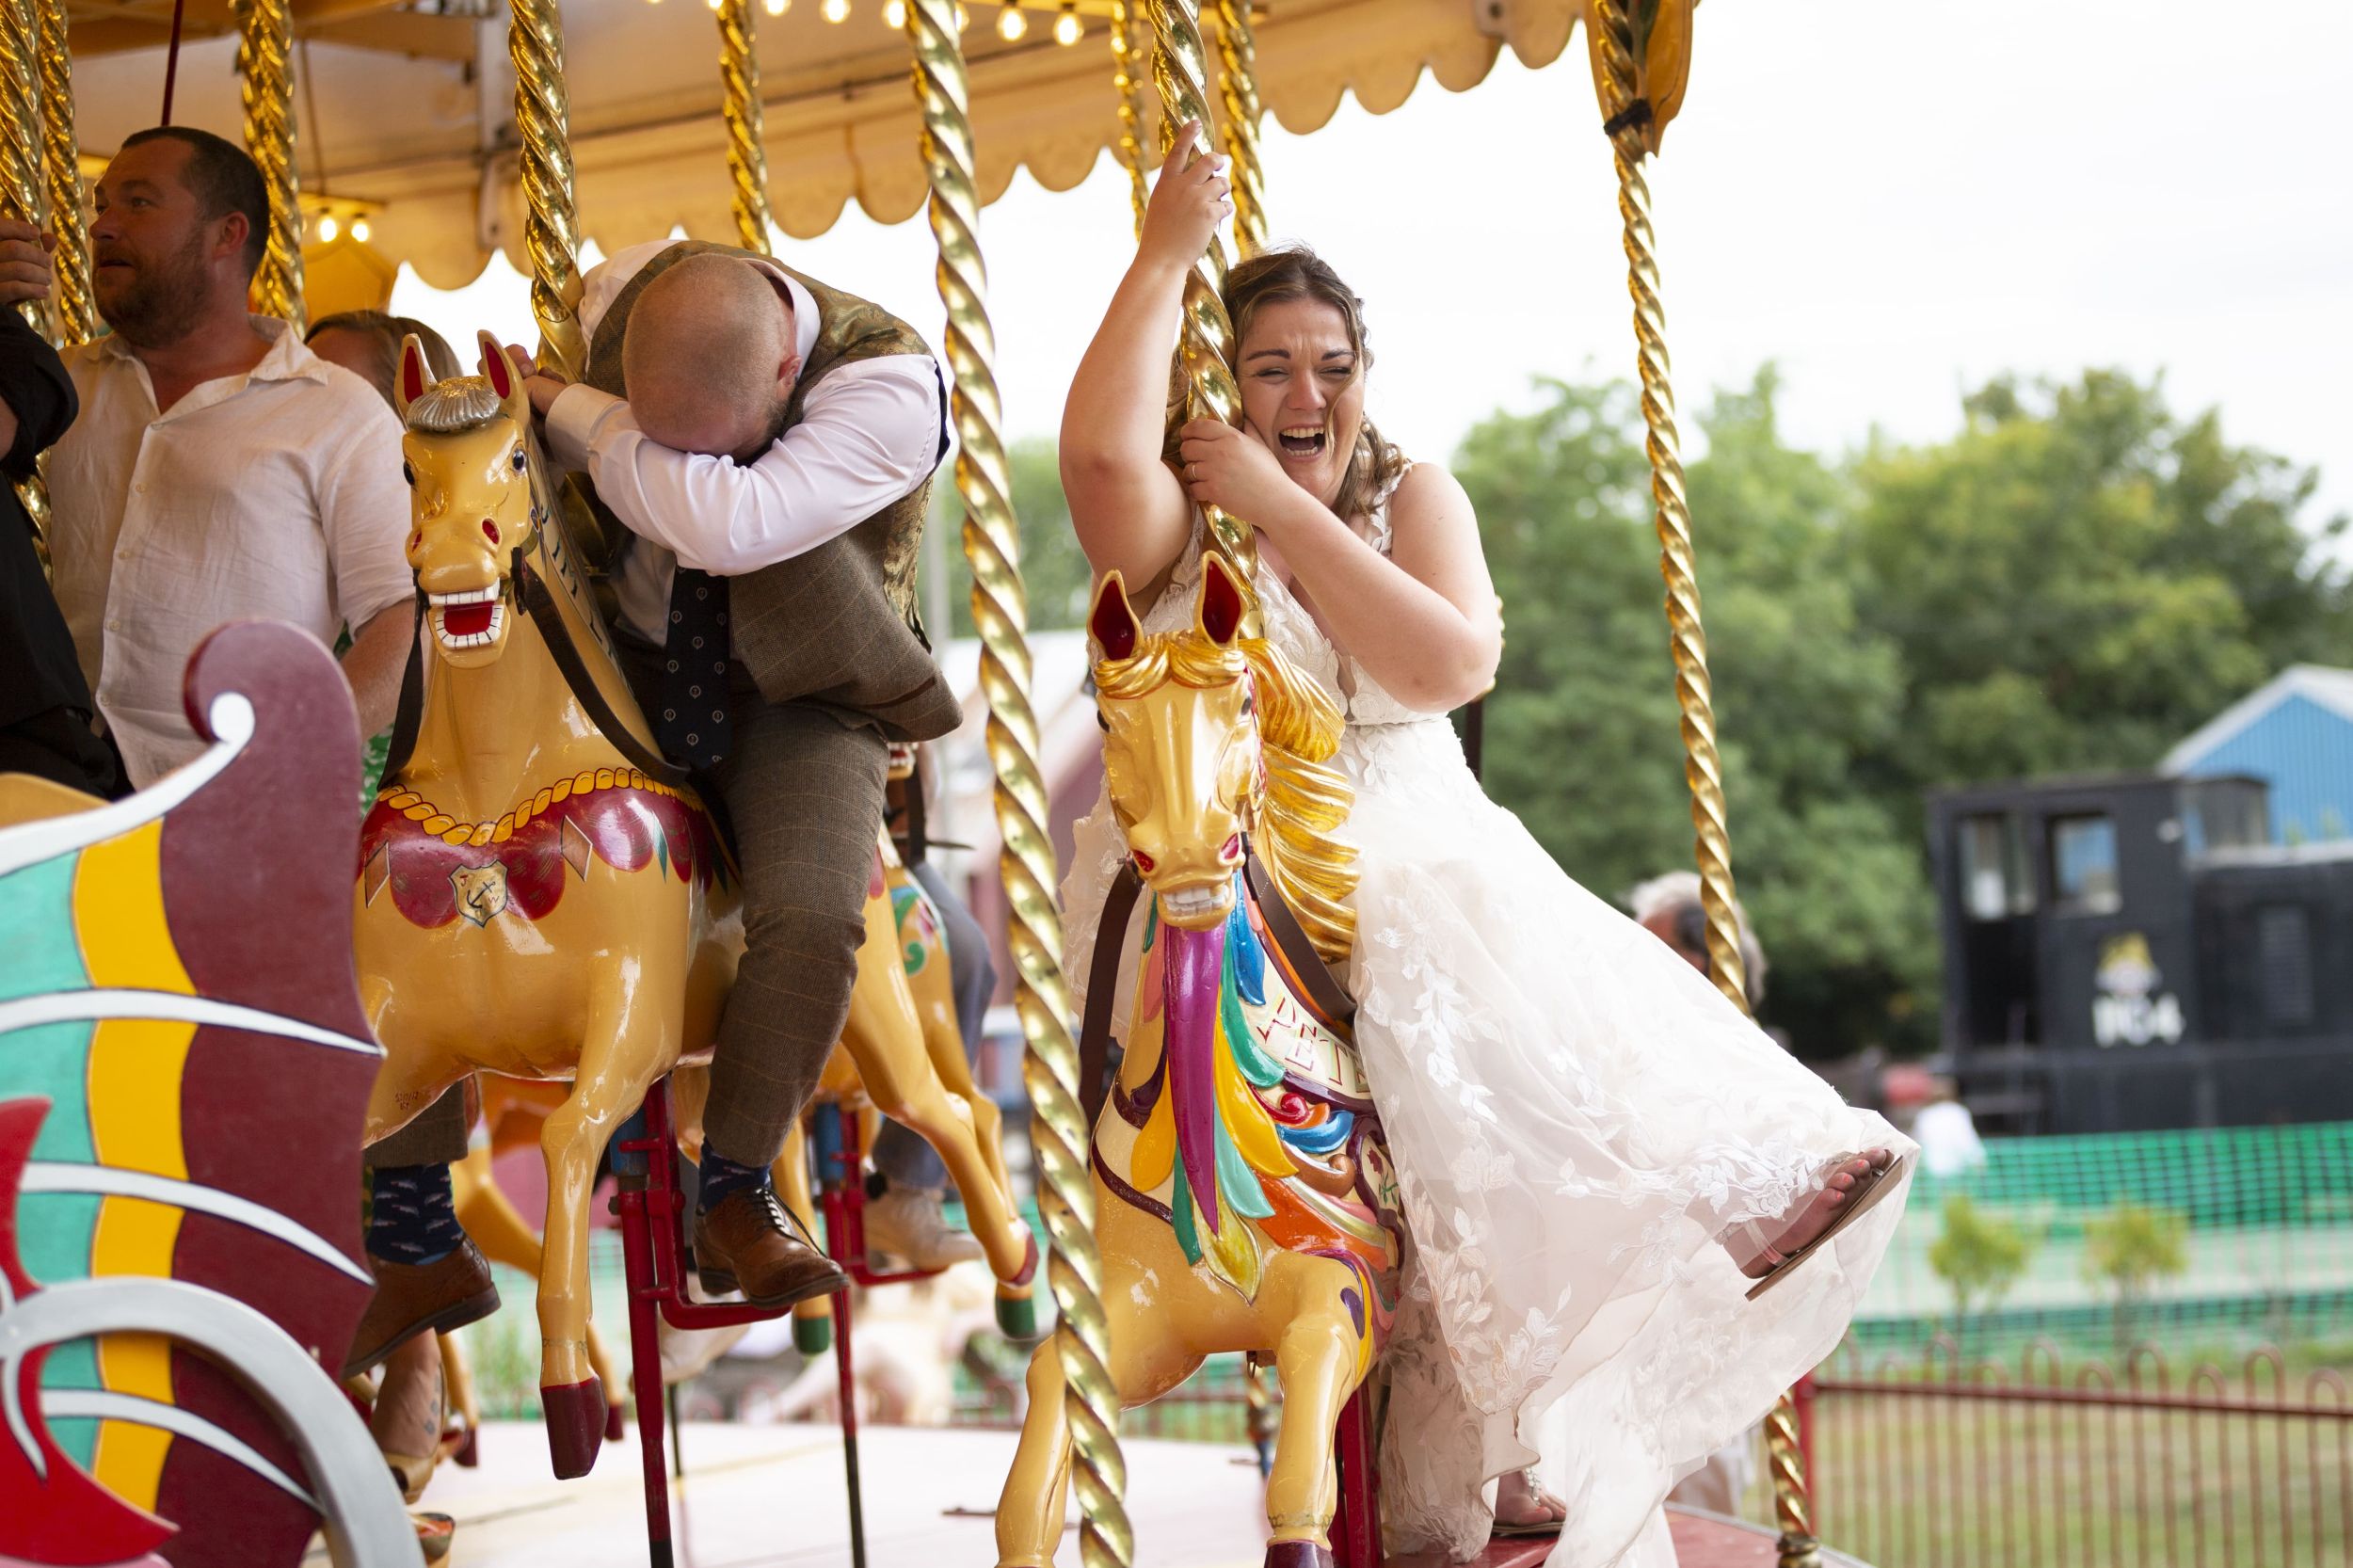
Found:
[549,240,941,645]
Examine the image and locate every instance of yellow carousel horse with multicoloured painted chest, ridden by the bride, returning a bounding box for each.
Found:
[998,555,1402,1568]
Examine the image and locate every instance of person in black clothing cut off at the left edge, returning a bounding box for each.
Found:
[0,283,122,798]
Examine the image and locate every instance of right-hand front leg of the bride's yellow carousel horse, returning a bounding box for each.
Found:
[1261,1253,1368,1568]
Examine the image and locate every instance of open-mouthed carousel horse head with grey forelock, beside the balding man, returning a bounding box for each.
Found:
[393,332,544,668]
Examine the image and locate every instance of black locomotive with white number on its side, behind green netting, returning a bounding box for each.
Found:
[1928,775,2353,1132]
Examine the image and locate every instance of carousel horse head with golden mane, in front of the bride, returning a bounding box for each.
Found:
[1087,553,1355,958]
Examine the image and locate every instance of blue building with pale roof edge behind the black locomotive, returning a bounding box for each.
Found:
[2158,664,2353,850]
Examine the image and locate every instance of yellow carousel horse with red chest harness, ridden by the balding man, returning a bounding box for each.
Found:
[353,332,1035,1476]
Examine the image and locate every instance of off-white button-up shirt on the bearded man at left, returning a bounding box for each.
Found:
[50,315,417,789]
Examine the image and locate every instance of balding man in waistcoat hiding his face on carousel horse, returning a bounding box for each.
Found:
[353,240,963,1366]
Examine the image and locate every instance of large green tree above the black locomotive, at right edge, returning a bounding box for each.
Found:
[1854,370,2353,796]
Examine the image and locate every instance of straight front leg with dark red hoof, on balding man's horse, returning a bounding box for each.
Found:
[539,965,685,1480]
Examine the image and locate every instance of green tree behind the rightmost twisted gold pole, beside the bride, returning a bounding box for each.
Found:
[1454,370,1934,1055]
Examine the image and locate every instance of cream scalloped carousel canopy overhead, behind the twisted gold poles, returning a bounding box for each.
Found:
[71,0,1584,287]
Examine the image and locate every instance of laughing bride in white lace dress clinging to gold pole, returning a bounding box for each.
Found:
[1062,125,1911,1568]
